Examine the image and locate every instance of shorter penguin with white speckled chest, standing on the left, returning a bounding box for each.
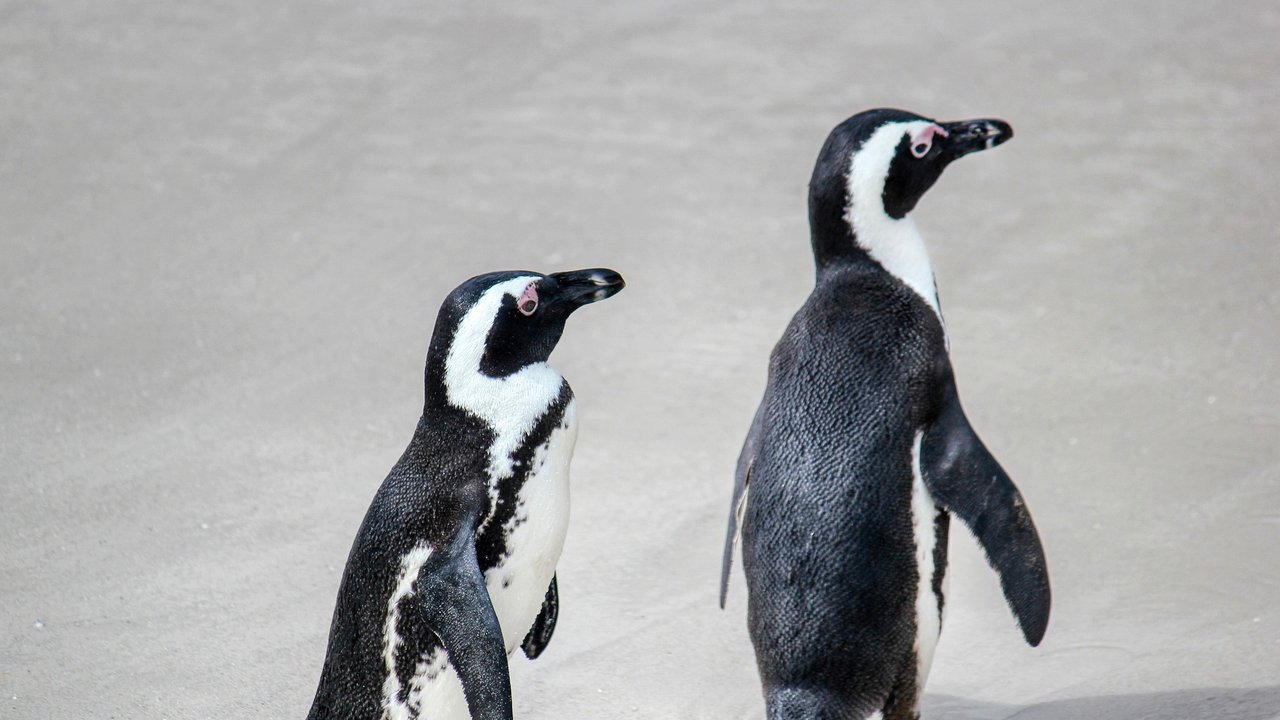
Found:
[308,269,623,720]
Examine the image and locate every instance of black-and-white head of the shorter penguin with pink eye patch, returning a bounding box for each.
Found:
[428,268,626,400]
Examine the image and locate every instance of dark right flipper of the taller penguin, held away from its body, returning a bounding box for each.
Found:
[920,383,1050,646]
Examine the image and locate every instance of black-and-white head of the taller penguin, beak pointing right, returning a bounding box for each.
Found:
[809,109,1014,258]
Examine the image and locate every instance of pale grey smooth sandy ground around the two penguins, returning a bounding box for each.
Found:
[0,0,1280,720]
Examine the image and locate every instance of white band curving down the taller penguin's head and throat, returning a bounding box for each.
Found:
[845,124,942,320]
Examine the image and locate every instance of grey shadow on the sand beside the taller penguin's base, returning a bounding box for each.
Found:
[920,685,1280,720]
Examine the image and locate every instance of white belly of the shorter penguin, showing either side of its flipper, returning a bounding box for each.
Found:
[410,400,577,720]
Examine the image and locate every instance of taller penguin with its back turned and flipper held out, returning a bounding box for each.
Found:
[719,109,1050,720]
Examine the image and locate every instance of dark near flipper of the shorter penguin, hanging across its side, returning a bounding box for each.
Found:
[415,532,512,720]
